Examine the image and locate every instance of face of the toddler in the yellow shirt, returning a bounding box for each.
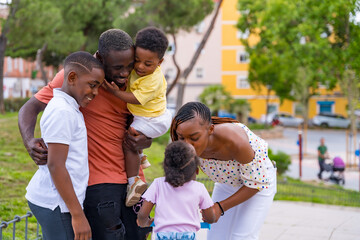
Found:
[134,47,164,77]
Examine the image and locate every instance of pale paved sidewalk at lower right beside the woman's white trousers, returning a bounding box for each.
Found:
[197,201,360,240]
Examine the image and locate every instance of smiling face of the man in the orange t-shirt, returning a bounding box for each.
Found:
[101,48,134,88]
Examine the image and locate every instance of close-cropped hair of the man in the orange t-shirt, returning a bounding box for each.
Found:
[98,28,134,57]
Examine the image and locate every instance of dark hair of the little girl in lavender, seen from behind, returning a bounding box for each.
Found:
[163,141,200,187]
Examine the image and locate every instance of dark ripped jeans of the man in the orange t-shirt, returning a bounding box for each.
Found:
[84,183,152,240]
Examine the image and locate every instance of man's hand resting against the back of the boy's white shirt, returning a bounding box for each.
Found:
[25,138,48,165]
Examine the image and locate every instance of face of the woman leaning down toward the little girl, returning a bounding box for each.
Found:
[176,116,213,156]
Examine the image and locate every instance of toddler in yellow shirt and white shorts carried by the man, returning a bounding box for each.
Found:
[105,27,172,207]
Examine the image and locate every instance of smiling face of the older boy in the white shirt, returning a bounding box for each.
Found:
[69,68,105,107]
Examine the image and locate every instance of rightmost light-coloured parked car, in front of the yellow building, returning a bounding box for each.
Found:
[312,113,350,128]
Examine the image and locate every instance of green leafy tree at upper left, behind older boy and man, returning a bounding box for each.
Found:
[7,0,131,81]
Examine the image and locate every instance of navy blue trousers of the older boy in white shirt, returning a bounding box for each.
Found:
[28,201,75,240]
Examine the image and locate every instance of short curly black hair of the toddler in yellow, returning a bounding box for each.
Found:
[135,27,169,59]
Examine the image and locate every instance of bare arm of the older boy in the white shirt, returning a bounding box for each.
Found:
[47,143,91,239]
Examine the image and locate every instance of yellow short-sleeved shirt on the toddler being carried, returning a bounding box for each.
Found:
[127,67,167,117]
